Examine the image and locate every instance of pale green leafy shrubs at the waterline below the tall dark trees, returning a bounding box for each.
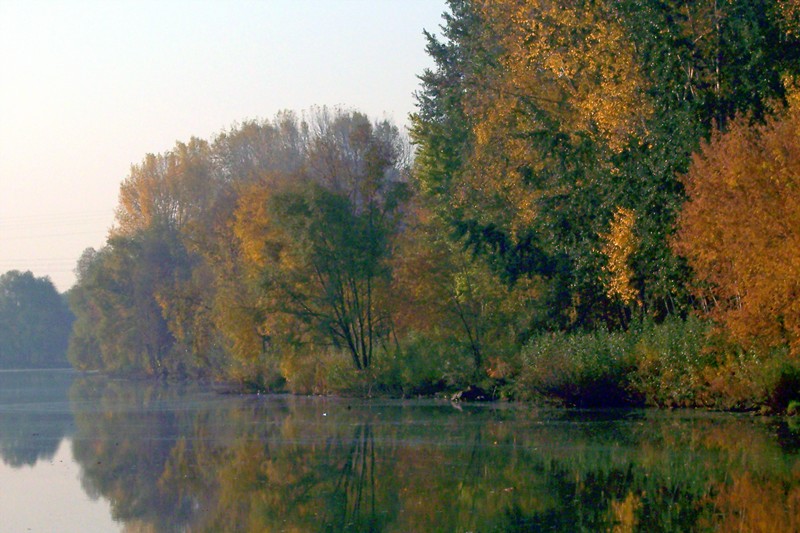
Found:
[515,318,712,407]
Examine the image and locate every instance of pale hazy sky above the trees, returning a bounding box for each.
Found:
[0,0,446,292]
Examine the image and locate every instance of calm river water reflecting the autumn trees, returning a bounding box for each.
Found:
[0,371,800,532]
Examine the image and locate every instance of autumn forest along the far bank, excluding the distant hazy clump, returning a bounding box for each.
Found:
[68,0,800,412]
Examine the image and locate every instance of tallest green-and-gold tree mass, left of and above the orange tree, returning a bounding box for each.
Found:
[412,0,800,329]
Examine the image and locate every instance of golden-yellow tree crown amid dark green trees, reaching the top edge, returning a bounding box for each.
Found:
[455,0,651,230]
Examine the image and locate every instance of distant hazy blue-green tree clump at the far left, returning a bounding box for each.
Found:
[0,270,73,368]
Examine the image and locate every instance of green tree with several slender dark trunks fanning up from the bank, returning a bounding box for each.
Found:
[264,186,388,369]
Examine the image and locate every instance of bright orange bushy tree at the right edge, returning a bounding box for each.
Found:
[676,97,800,356]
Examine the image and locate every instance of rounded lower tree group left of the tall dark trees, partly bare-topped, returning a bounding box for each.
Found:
[70,109,408,386]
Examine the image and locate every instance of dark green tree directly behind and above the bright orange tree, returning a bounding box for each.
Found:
[619,0,800,314]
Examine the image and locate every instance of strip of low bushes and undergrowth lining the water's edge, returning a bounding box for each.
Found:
[227,318,800,414]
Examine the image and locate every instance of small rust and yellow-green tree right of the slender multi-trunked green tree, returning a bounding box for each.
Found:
[390,202,541,383]
